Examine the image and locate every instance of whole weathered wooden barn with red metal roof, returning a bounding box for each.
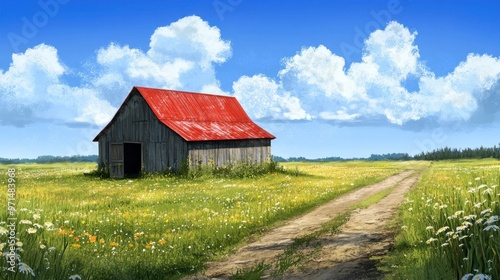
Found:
[93,87,275,178]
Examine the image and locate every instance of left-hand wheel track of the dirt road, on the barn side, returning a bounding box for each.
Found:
[185,170,418,280]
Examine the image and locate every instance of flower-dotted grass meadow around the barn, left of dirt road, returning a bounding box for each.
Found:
[0,162,416,279]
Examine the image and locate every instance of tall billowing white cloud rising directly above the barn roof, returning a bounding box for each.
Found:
[93,16,231,101]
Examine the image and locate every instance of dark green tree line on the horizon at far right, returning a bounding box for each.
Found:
[413,145,500,160]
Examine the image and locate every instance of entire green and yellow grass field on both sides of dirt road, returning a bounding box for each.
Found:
[0,160,500,279]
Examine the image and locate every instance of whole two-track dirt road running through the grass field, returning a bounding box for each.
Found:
[186,171,418,280]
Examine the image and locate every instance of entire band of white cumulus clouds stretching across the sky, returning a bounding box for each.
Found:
[0,16,500,129]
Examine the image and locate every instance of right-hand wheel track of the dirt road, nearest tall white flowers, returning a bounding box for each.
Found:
[280,171,419,280]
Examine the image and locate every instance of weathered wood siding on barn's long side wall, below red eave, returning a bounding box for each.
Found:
[188,139,271,166]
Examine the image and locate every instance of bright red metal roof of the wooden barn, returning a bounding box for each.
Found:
[94,87,275,141]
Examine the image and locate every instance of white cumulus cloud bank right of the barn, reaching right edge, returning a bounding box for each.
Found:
[237,19,500,125]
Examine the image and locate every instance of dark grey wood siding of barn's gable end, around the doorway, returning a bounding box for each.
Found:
[99,93,188,172]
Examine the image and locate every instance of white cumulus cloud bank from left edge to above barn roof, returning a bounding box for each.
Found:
[0,16,231,126]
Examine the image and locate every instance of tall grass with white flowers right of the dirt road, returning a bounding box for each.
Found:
[386,160,500,279]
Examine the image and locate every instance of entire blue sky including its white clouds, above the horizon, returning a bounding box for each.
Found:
[0,0,500,158]
